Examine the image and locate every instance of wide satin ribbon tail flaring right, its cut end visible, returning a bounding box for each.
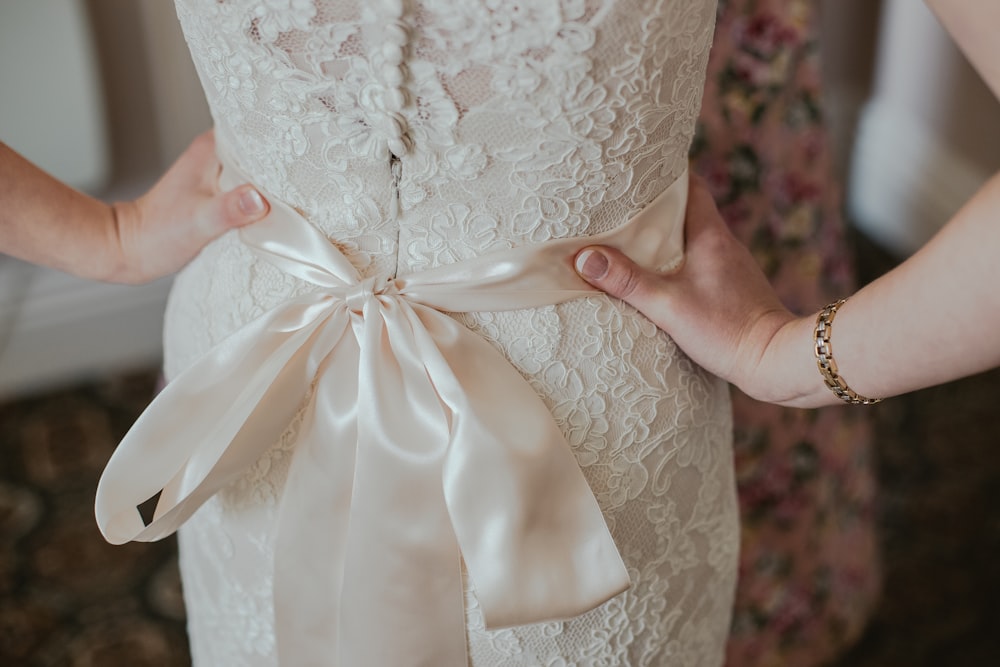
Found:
[413,306,629,627]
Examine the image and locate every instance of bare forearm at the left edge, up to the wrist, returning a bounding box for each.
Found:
[0,143,126,280]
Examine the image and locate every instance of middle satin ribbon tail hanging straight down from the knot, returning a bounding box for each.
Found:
[337,300,468,667]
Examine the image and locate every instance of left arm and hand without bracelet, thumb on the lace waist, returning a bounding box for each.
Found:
[0,132,268,283]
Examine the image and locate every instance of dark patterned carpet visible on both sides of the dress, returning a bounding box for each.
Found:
[0,236,1000,667]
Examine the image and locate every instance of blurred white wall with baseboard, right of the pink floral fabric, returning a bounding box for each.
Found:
[848,0,1000,256]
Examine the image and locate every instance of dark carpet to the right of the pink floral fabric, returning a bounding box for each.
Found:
[837,234,1000,667]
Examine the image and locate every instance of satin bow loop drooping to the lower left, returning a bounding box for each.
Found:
[94,299,338,544]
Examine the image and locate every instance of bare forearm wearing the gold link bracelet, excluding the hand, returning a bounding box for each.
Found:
[761,176,1000,407]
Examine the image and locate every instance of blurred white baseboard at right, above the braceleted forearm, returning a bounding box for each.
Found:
[847,99,991,257]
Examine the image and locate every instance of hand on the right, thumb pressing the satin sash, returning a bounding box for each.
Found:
[576,176,815,402]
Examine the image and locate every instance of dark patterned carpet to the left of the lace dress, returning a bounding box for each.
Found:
[0,371,190,667]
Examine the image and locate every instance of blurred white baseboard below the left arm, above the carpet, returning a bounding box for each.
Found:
[0,256,170,398]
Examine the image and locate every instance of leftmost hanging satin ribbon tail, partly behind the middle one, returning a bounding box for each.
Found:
[274,316,360,667]
